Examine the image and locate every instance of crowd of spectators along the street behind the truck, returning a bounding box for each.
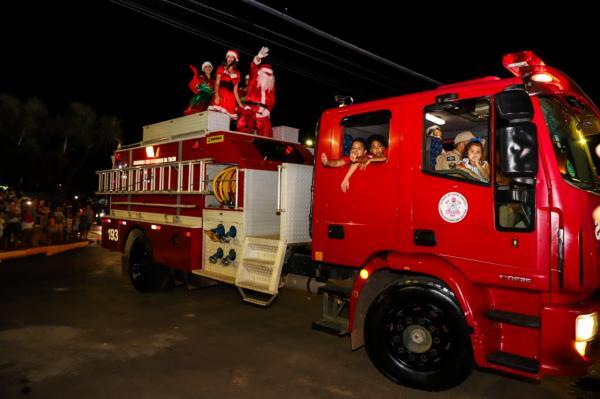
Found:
[0,190,96,251]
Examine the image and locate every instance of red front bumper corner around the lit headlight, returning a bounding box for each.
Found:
[540,299,600,376]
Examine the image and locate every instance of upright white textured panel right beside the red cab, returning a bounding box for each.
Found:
[281,164,313,244]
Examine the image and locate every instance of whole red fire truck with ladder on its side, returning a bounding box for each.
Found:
[98,52,600,390]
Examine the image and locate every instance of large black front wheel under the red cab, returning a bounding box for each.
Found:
[365,283,473,391]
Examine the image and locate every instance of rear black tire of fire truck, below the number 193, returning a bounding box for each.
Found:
[127,236,173,292]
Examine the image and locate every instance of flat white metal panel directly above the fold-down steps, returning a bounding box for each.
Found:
[244,169,280,236]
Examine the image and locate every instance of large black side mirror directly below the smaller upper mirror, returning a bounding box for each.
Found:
[496,122,538,178]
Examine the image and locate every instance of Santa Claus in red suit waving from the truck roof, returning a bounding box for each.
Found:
[237,47,275,137]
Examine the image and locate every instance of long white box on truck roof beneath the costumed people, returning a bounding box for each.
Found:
[143,111,229,141]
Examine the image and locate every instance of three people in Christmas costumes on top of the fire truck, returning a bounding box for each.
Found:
[183,47,275,137]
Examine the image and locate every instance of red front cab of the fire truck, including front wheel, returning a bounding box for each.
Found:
[312,52,600,389]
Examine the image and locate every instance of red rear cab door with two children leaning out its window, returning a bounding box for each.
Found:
[313,108,399,267]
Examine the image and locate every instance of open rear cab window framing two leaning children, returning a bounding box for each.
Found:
[341,110,392,157]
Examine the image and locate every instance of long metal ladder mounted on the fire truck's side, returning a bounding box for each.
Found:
[96,158,212,195]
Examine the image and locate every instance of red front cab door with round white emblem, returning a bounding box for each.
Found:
[412,97,548,288]
